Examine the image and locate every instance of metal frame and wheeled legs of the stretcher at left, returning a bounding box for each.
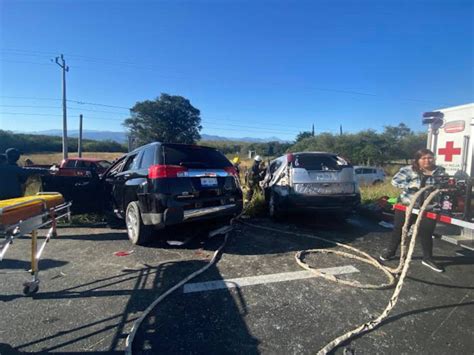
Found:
[0,192,72,296]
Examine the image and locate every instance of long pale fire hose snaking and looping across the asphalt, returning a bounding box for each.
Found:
[125,186,446,355]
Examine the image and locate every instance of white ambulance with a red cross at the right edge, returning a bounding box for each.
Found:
[423,103,474,250]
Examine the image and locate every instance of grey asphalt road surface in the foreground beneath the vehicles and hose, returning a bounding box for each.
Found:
[0,217,474,354]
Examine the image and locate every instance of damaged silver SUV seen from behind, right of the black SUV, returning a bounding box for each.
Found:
[263,152,360,218]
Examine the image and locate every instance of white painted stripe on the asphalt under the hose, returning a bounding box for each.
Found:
[183,265,359,293]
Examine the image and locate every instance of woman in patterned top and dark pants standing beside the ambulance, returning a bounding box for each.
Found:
[379,149,446,272]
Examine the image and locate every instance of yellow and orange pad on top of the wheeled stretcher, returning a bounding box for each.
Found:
[0,193,64,225]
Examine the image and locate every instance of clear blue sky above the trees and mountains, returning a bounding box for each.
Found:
[0,0,474,139]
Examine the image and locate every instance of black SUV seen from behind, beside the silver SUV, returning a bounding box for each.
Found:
[103,142,242,244]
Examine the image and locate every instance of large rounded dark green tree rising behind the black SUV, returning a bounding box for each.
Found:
[124,94,202,145]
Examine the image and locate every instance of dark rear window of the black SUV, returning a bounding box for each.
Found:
[163,144,231,169]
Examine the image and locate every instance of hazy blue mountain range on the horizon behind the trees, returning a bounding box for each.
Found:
[24,129,287,143]
